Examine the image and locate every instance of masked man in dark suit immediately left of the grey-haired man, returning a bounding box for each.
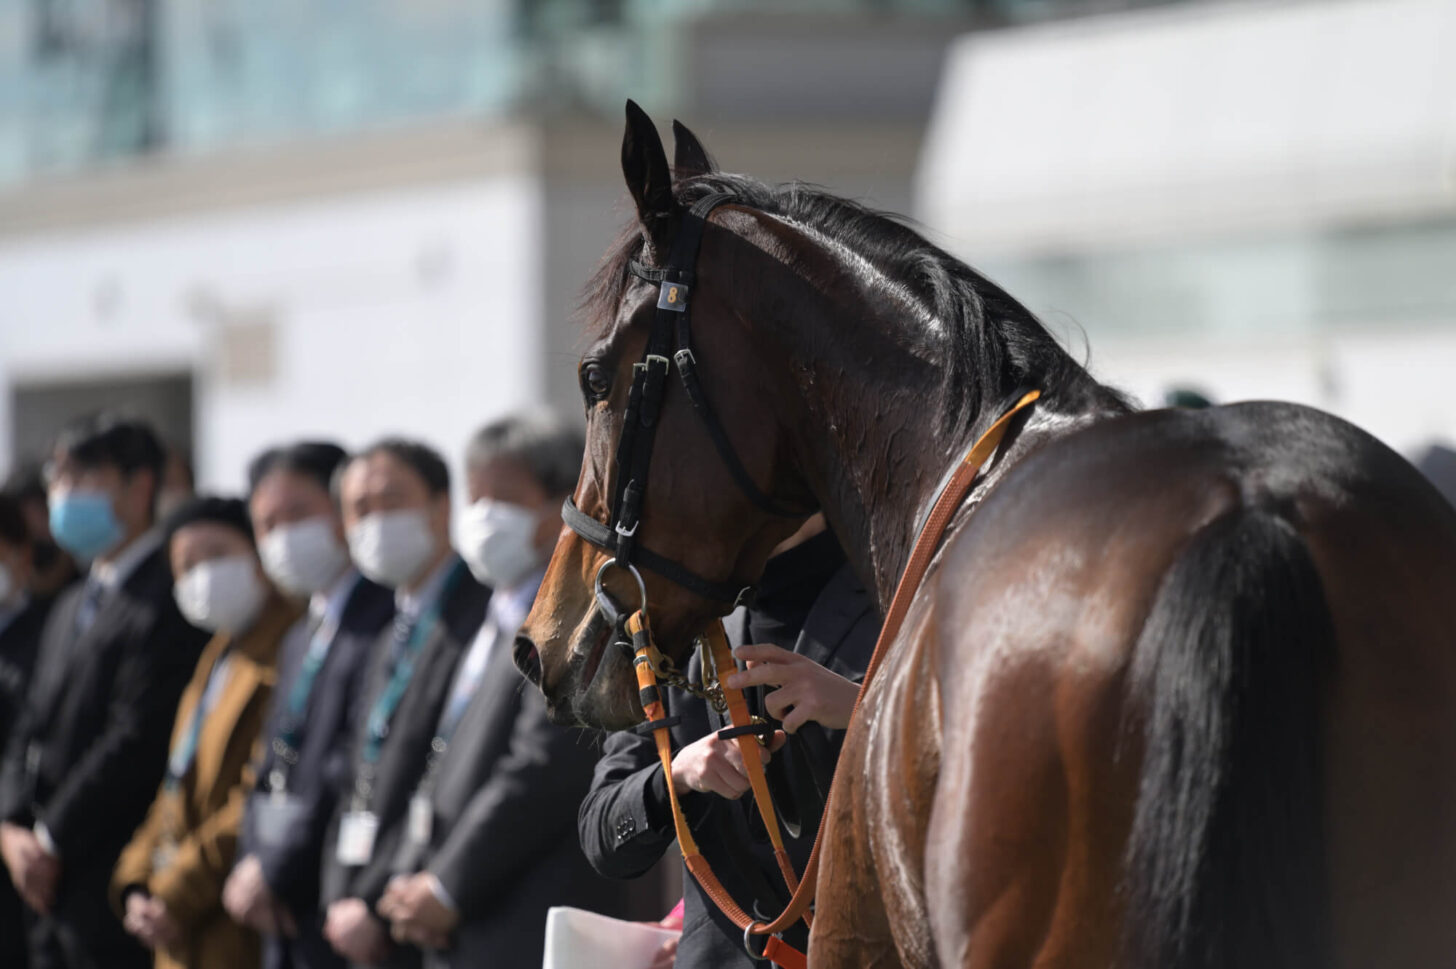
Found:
[322,438,491,966]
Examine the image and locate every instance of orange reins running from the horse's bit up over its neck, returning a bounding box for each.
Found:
[626,390,1041,969]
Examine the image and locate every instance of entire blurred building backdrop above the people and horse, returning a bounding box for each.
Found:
[0,0,1456,489]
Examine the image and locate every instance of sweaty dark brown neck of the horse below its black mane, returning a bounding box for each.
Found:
[738,205,1125,611]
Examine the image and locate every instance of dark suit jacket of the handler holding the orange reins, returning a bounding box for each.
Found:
[577,566,881,969]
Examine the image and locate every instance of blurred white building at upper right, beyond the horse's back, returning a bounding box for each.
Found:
[916,0,1456,454]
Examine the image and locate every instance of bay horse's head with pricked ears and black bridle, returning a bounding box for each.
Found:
[515,102,814,729]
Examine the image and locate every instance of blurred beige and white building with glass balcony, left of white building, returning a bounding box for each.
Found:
[0,0,1013,487]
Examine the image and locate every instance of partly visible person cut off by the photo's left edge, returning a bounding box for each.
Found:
[0,495,51,969]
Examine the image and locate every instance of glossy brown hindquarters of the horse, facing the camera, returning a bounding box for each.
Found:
[844,403,1456,966]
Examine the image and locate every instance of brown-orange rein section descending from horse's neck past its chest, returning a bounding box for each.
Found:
[745,390,1041,936]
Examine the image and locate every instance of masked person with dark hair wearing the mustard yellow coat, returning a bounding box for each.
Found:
[111,498,301,969]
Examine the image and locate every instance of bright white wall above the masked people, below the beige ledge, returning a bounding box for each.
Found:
[0,168,545,490]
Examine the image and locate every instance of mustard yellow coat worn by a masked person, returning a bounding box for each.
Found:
[111,587,301,969]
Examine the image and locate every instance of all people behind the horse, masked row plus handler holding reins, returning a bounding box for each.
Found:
[0,413,879,969]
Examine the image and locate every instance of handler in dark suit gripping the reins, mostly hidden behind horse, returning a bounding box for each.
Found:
[577,515,881,969]
